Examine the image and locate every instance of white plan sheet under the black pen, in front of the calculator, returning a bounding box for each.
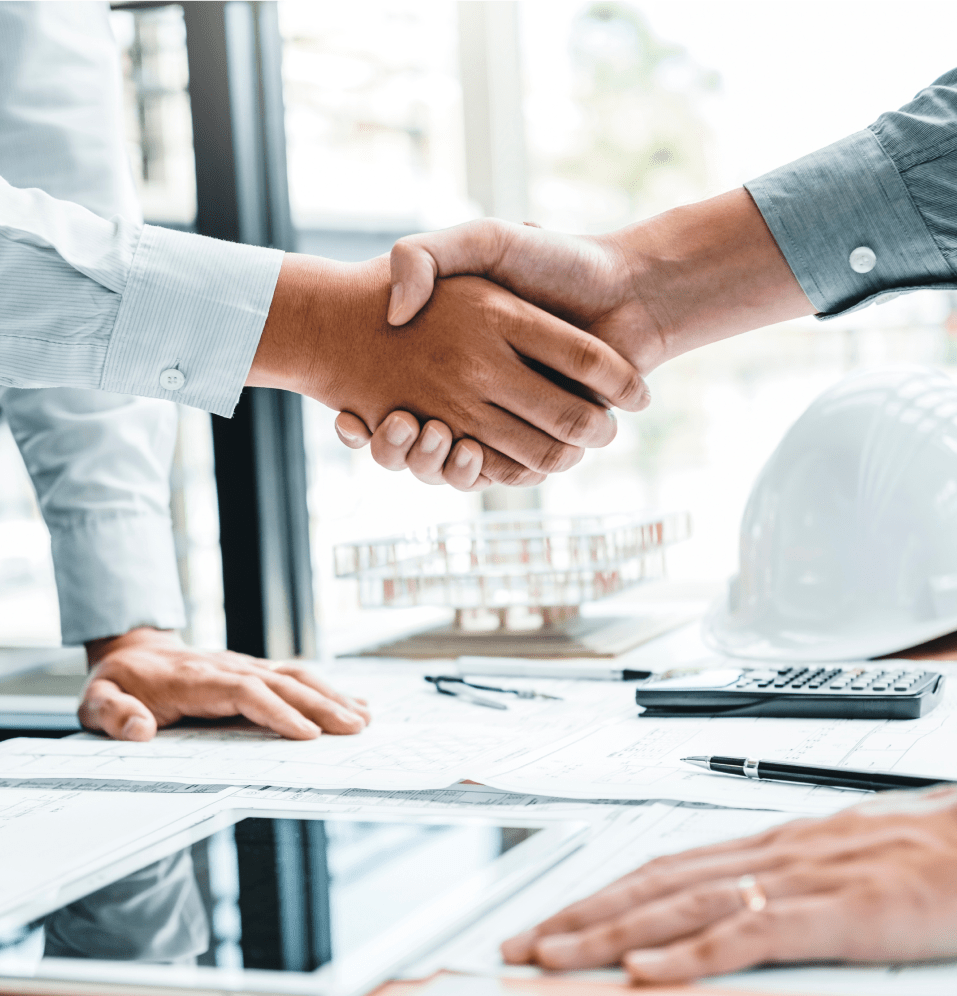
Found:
[472,681,957,813]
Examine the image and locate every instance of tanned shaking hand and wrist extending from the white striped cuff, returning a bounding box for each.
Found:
[247,254,643,483]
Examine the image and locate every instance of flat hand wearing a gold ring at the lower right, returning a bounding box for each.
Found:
[502,787,957,984]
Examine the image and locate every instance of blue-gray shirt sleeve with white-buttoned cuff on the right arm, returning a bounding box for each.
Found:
[745,70,957,318]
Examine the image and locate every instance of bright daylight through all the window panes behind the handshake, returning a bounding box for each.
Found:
[0,0,957,646]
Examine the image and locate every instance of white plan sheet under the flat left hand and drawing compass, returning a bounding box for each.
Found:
[0,662,635,789]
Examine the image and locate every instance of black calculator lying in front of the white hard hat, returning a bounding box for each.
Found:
[635,660,944,719]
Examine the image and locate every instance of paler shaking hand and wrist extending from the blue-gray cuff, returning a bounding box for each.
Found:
[337,188,814,486]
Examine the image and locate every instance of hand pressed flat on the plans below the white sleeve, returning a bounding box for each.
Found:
[79,627,371,740]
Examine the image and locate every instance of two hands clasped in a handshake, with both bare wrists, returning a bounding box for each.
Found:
[247,189,814,491]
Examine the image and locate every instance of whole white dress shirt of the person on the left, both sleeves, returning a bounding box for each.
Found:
[0,0,281,643]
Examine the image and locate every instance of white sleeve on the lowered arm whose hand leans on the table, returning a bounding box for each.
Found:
[0,388,186,644]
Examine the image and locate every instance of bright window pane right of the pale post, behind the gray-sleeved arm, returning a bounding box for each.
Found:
[519,0,957,582]
